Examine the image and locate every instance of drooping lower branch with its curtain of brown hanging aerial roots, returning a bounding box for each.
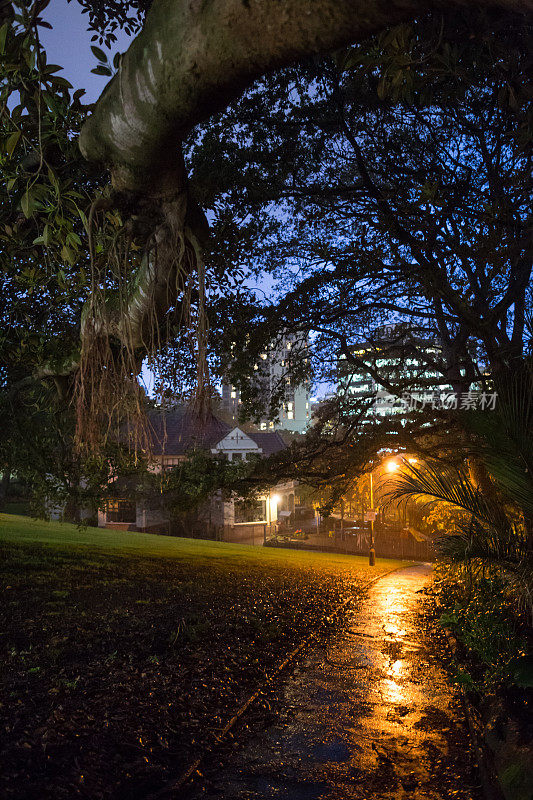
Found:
[75,184,211,452]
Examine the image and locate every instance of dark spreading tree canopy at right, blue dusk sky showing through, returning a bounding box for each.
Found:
[188,12,533,406]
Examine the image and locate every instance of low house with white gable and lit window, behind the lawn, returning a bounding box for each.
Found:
[98,406,296,543]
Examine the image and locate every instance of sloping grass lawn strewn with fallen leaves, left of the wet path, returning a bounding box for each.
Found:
[0,514,408,800]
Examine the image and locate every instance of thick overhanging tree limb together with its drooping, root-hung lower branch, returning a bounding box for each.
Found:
[69,0,533,424]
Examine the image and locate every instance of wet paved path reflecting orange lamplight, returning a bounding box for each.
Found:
[185,565,481,800]
